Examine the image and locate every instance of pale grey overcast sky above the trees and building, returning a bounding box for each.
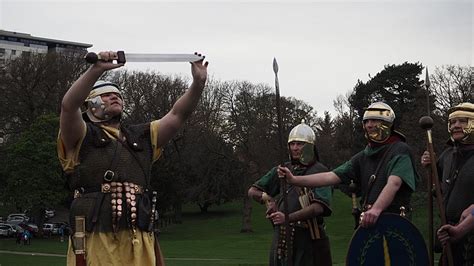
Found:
[0,0,474,115]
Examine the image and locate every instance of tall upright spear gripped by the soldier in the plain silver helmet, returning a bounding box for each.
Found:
[273,58,293,266]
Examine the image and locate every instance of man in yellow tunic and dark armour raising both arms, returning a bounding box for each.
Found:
[57,51,208,265]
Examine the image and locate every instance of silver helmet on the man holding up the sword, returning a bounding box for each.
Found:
[85,80,123,122]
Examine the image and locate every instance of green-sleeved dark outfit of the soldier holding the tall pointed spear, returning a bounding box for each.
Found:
[253,163,332,266]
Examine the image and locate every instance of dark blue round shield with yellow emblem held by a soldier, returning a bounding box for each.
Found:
[346,213,429,266]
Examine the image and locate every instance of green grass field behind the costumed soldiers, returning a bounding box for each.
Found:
[0,191,438,266]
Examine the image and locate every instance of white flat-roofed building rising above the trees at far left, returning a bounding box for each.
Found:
[0,30,92,65]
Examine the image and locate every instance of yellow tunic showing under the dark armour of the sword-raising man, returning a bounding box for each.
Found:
[57,120,164,266]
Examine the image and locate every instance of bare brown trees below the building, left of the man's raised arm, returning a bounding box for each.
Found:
[0,53,87,137]
